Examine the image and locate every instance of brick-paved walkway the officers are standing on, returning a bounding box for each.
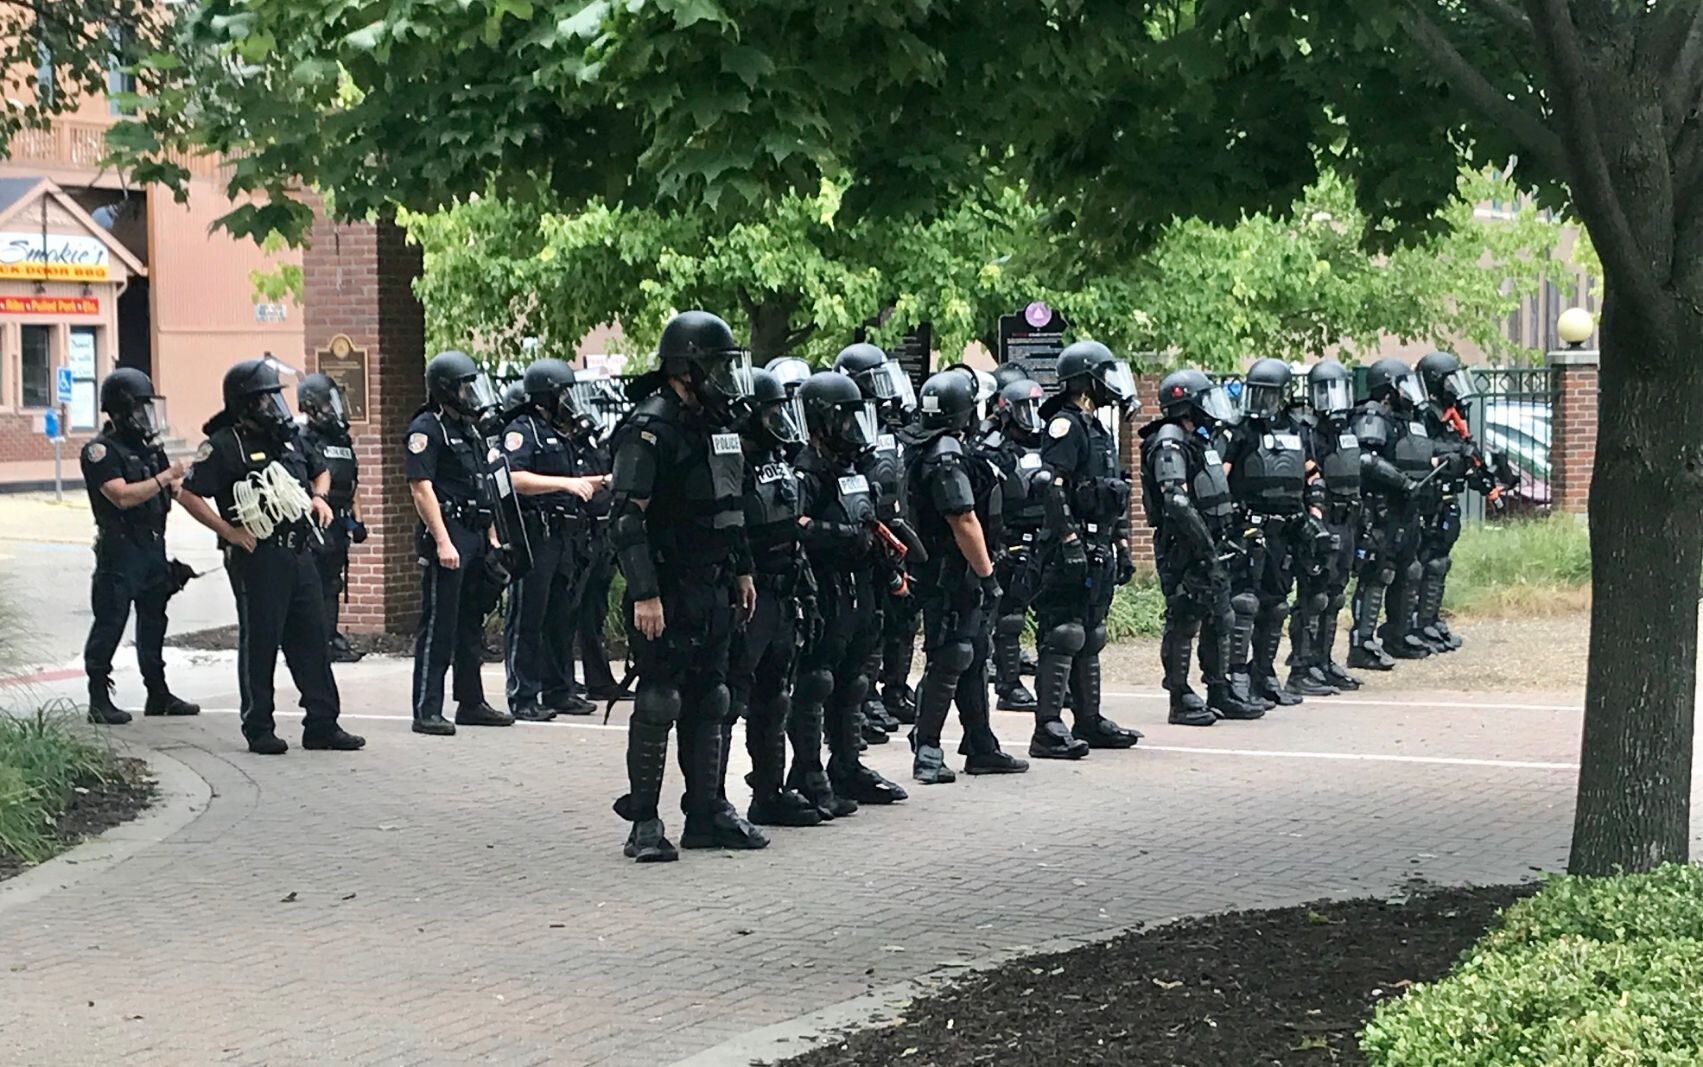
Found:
[0,657,1696,1067]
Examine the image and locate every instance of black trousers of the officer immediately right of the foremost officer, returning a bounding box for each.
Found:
[727,573,799,795]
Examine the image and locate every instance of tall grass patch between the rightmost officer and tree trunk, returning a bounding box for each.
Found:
[1442,516,1591,618]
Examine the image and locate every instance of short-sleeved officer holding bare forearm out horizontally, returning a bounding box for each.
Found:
[502,359,594,722]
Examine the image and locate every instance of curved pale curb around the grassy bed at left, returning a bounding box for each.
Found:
[0,749,213,914]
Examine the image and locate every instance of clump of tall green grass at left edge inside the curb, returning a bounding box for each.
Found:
[0,705,116,863]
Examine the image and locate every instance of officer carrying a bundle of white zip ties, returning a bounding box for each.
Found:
[179,359,366,756]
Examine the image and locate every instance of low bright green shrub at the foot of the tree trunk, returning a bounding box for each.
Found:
[1361,866,1703,1067]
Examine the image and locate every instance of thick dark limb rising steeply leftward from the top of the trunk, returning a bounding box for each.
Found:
[1526,0,1662,317]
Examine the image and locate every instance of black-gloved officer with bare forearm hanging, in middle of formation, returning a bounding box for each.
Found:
[906,371,1039,785]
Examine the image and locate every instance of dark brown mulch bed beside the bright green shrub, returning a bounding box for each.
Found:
[783,885,1536,1067]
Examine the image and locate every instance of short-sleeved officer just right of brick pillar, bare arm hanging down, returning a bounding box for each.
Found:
[402,352,514,737]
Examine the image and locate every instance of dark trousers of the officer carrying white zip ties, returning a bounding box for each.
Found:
[225,534,339,740]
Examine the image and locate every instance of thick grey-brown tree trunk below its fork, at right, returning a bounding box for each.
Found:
[1568,287,1703,875]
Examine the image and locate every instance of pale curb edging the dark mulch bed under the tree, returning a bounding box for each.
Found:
[669,916,1158,1067]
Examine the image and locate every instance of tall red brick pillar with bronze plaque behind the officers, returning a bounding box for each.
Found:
[301,216,426,633]
